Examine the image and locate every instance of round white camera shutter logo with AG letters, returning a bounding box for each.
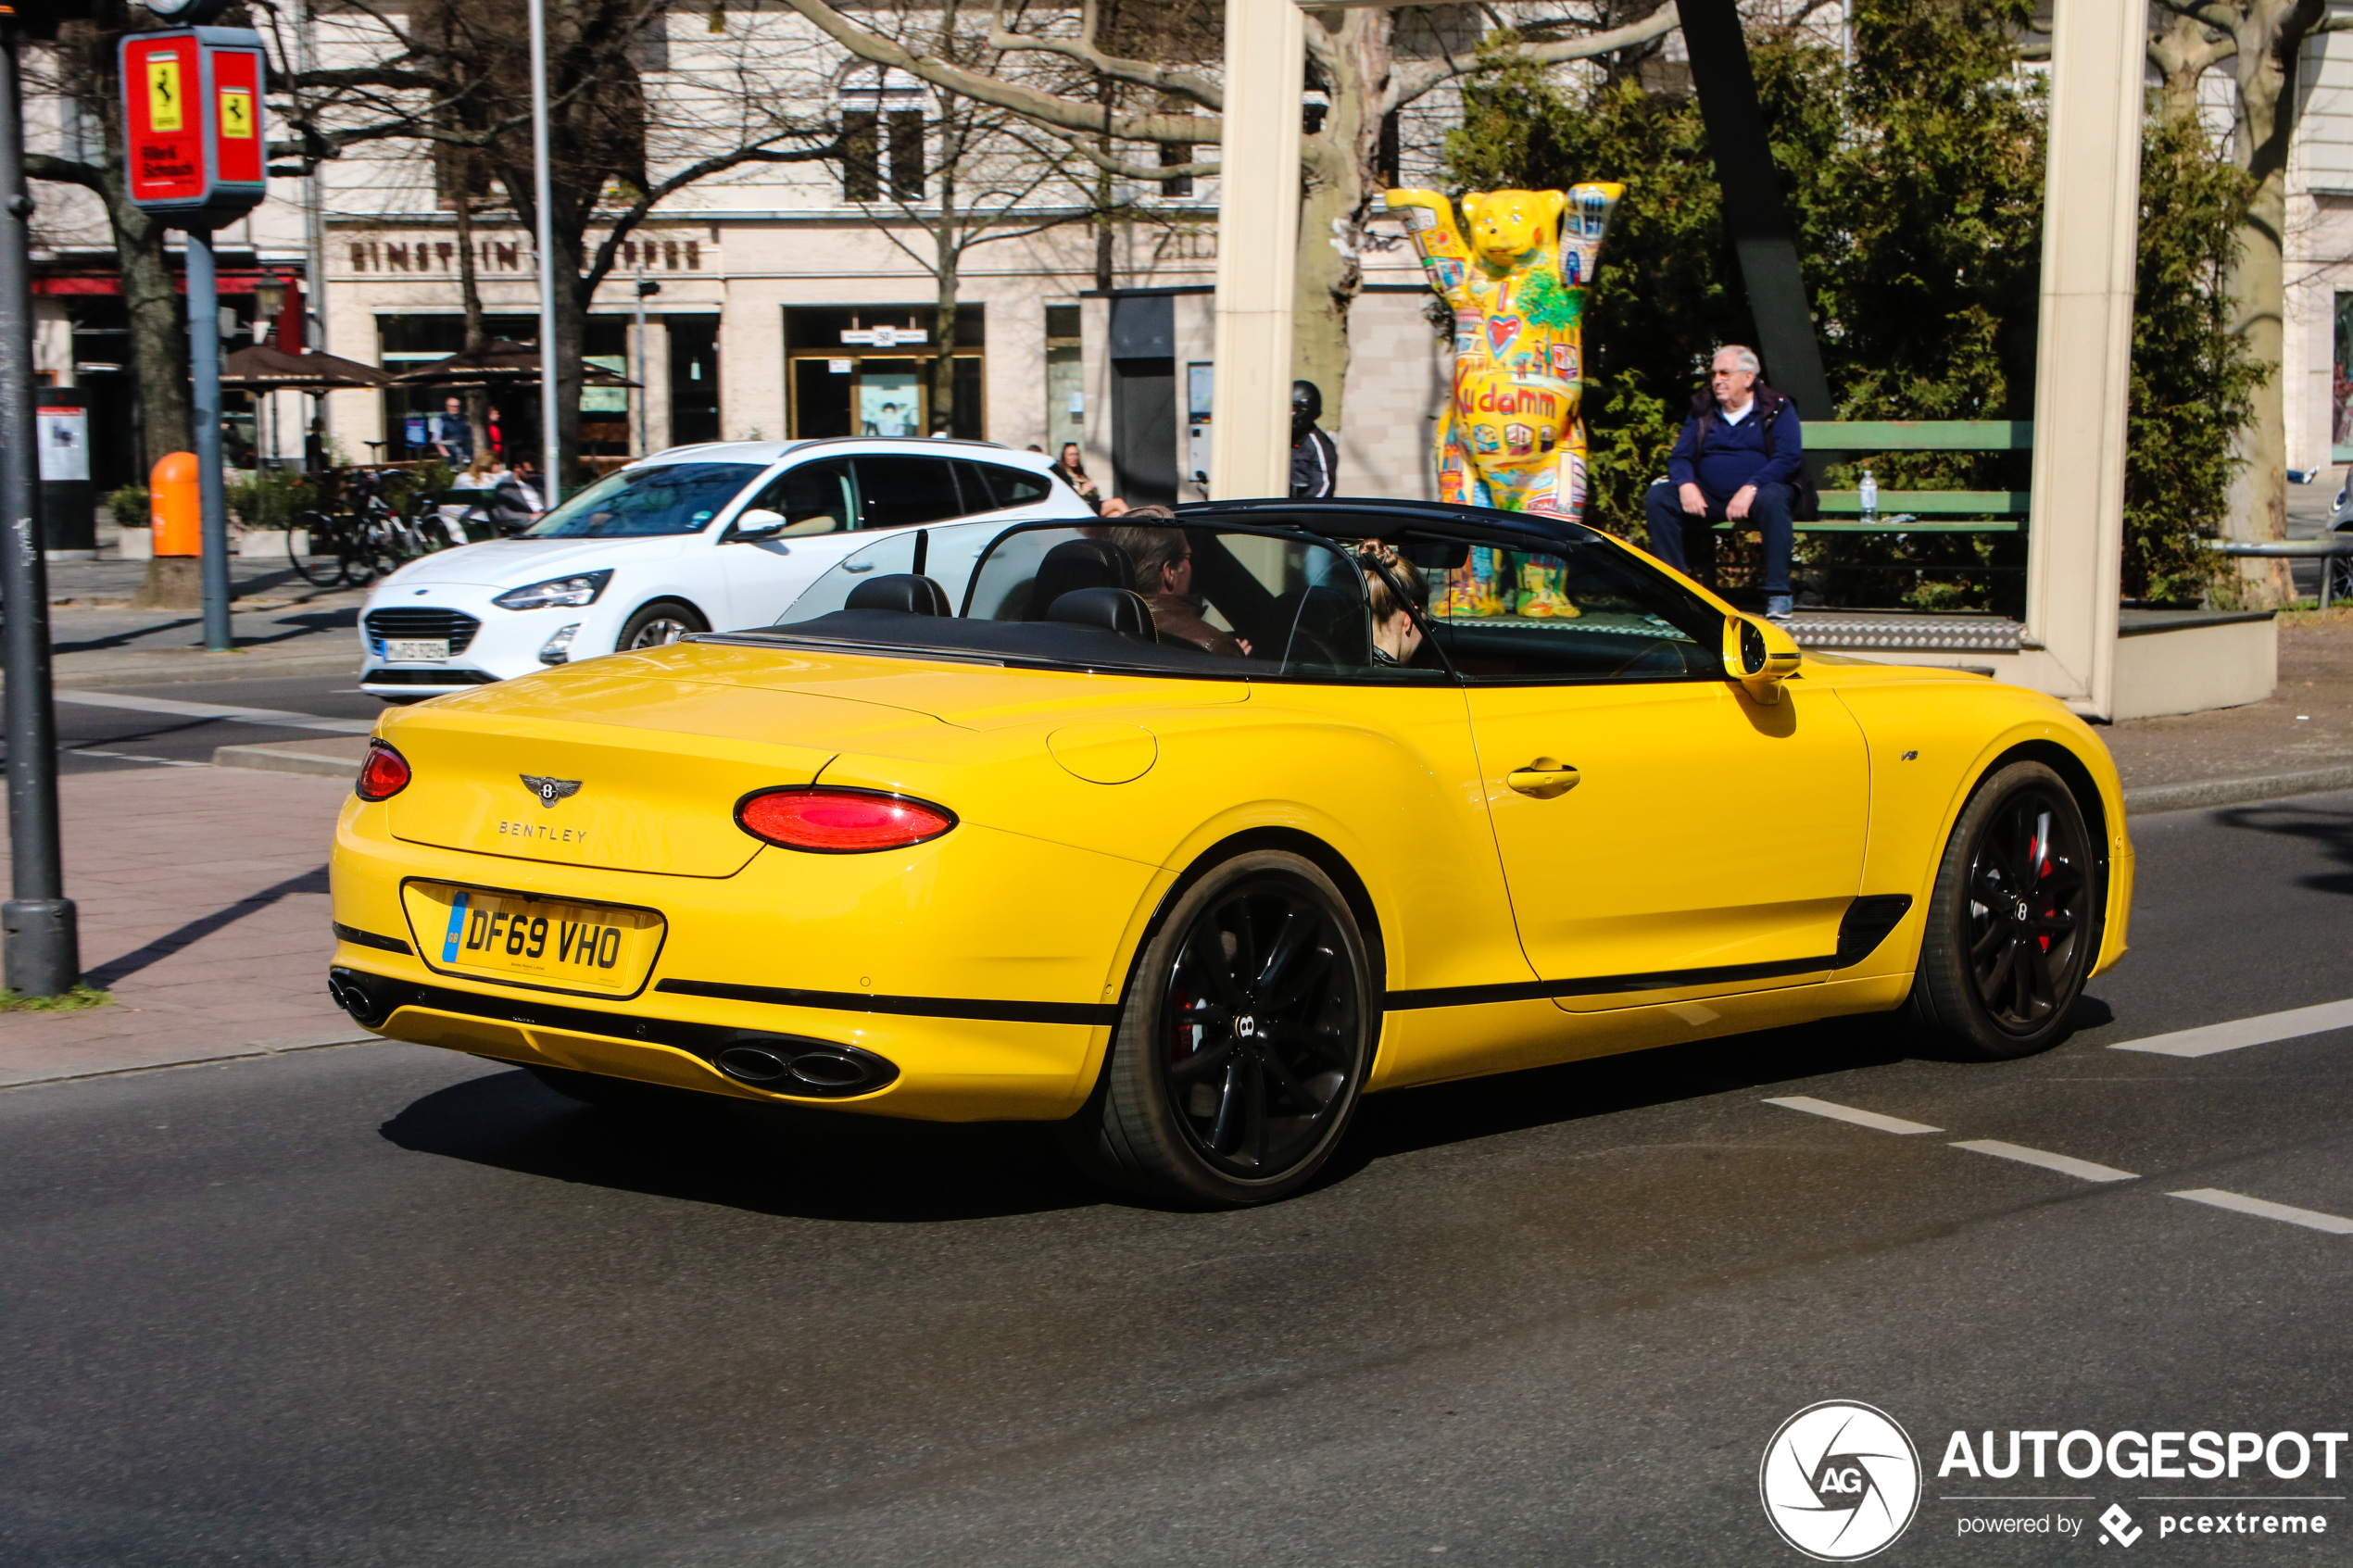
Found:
[1757,1399,1920,1563]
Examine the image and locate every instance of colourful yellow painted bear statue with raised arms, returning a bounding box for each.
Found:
[1389,186,1626,520]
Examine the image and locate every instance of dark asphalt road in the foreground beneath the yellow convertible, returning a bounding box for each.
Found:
[0,795,2353,1568]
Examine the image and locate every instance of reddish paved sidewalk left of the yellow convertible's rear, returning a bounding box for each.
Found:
[0,766,371,1086]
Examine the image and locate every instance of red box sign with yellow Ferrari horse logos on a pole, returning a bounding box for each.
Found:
[120,28,269,228]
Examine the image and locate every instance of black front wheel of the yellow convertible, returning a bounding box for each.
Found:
[1910,761,2104,1060]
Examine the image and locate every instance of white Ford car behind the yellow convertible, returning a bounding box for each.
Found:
[360,437,1092,700]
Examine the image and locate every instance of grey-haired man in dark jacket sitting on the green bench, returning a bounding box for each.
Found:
[1642,344,1805,621]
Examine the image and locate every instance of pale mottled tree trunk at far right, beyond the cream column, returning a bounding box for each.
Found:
[2223,0,2322,607]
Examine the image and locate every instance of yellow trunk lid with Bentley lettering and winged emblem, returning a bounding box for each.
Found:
[381,665,938,879]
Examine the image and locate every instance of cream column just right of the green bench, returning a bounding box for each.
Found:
[2026,0,2148,717]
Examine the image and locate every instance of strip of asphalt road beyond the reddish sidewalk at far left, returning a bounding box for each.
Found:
[0,674,384,773]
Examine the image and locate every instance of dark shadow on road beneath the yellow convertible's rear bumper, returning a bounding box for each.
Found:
[381,1072,1103,1224]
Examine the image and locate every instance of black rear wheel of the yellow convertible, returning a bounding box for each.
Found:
[1066,851,1378,1206]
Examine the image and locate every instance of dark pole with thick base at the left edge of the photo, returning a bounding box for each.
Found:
[0,21,82,997]
